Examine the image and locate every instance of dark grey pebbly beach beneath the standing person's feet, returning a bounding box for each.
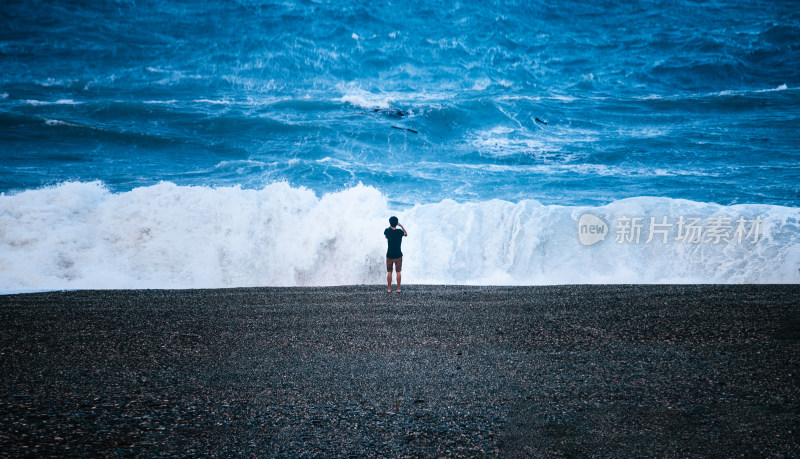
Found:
[0,285,800,457]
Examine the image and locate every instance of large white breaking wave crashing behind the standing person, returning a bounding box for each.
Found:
[0,182,800,291]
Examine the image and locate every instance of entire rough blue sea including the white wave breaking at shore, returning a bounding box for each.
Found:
[0,0,800,290]
